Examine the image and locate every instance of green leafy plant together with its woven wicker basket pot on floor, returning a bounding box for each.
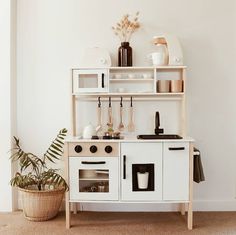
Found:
[10,129,68,221]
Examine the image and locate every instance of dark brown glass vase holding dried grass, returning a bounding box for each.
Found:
[118,42,132,67]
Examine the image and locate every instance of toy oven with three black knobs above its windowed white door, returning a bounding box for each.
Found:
[69,142,119,201]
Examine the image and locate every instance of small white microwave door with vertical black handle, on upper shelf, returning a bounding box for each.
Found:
[73,69,108,94]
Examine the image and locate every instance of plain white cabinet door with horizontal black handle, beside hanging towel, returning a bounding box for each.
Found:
[163,142,189,201]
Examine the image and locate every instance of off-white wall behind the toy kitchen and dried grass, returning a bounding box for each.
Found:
[17,0,236,210]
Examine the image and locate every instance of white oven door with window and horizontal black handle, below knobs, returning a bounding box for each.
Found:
[69,157,119,201]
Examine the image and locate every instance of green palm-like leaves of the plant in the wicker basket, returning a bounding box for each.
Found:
[10,128,69,191]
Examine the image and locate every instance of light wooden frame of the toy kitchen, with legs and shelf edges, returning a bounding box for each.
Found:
[64,66,193,230]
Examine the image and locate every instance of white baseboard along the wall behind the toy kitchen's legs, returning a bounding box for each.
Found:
[59,200,236,212]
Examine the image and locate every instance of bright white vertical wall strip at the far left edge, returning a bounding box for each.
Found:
[0,0,16,211]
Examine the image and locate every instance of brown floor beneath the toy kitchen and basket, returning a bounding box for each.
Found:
[0,212,236,235]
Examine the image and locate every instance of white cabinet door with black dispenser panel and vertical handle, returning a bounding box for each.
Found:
[121,143,162,201]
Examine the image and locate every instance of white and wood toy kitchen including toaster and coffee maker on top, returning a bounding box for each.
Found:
[64,36,194,229]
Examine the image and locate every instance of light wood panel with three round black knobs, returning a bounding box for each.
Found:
[69,142,119,157]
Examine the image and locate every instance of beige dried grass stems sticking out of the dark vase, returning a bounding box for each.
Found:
[112,12,140,42]
